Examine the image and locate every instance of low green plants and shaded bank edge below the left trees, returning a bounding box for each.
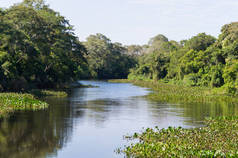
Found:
[0,82,99,118]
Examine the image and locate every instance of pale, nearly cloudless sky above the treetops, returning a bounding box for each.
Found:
[0,0,238,45]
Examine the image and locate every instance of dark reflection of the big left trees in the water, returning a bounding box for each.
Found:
[0,99,73,158]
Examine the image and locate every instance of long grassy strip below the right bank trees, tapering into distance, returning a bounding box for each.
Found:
[109,79,238,104]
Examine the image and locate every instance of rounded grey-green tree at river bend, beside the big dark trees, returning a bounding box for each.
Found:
[84,34,136,79]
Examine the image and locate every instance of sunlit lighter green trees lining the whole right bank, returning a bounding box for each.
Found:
[129,23,238,94]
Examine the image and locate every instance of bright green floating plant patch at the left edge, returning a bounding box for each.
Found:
[0,93,48,117]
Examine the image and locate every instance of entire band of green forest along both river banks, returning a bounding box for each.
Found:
[0,0,238,93]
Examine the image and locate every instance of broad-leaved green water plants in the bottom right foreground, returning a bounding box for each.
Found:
[117,117,238,158]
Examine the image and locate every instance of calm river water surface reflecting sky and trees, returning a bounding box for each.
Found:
[0,81,238,158]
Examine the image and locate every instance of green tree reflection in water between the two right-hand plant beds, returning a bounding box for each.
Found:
[148,100,238,126]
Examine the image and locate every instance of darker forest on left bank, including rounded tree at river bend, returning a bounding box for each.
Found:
[0,0,135,91]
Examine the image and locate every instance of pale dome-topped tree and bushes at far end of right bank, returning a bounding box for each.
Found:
[128,35,179,80]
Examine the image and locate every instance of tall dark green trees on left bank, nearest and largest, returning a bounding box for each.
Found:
[0,0,89,91]
